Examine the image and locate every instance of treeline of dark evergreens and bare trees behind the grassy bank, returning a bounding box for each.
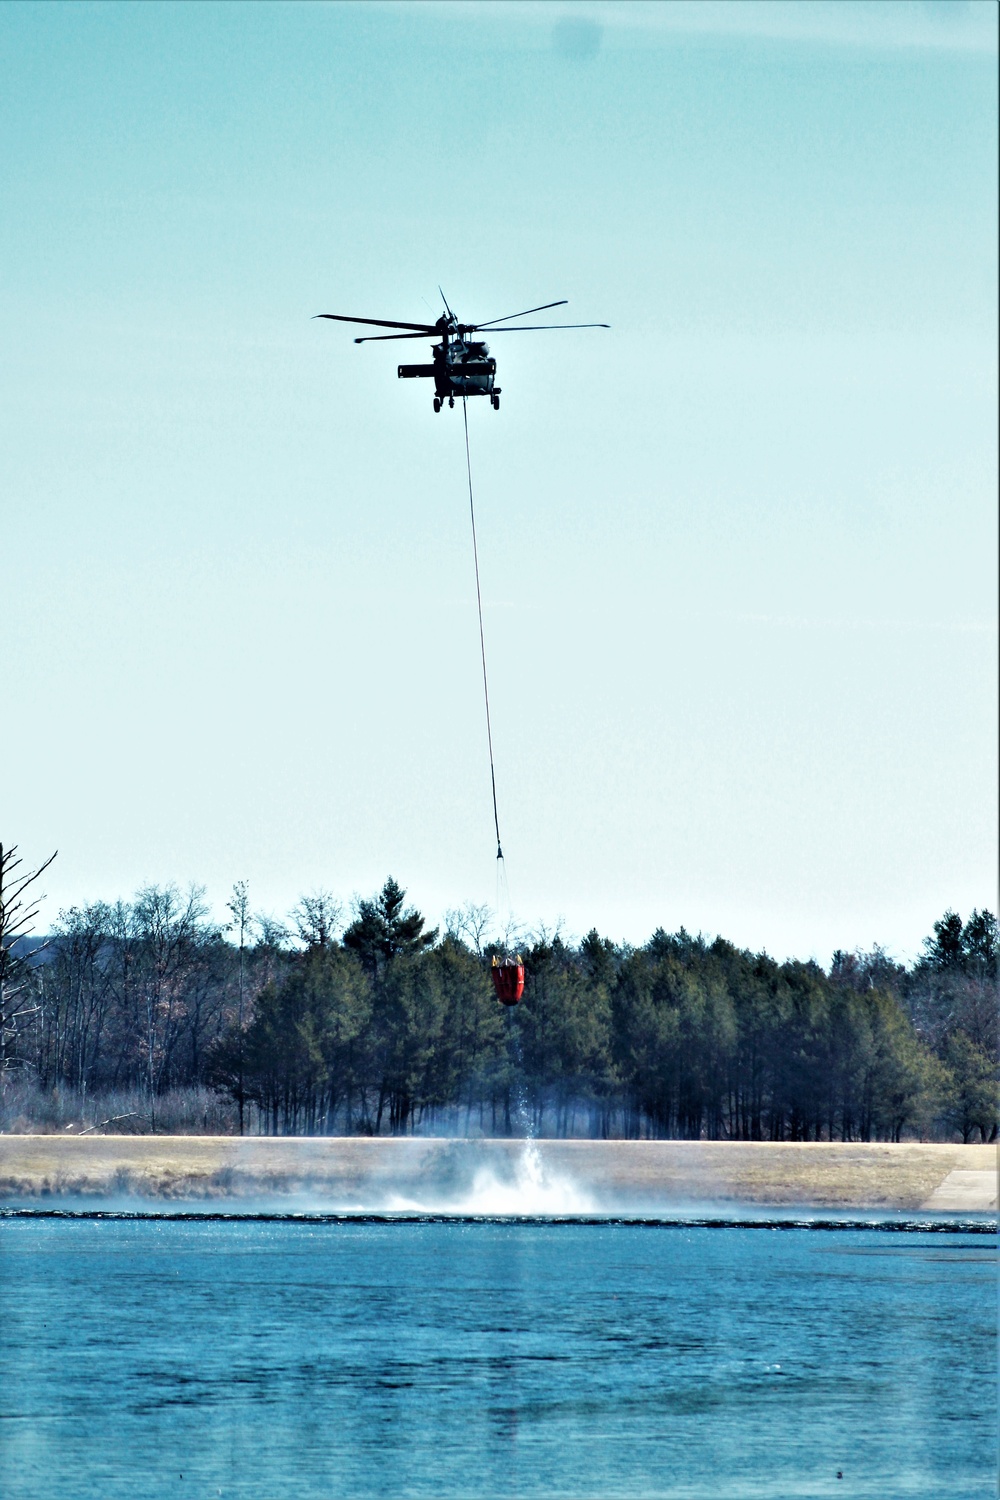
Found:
[0,879,997,1142]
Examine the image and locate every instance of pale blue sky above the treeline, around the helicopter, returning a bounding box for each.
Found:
[0,0,997,962]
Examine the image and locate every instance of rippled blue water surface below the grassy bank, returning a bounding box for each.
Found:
[0,1218,996,1500]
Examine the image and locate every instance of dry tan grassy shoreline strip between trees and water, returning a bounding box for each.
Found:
[0,1136,999,1214]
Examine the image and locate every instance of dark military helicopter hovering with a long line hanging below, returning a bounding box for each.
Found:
[316,293,610,411]
